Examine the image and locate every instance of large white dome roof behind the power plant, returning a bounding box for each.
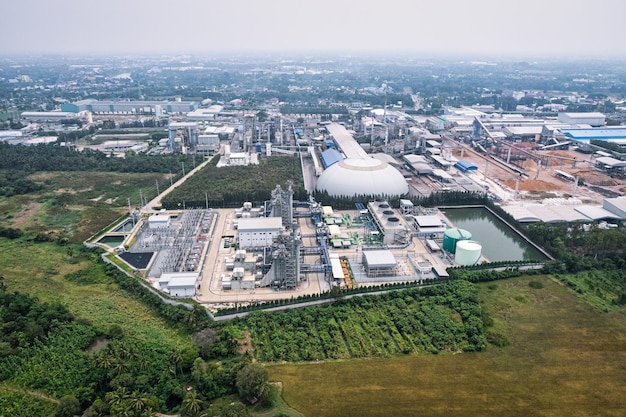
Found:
[316,158,409,197]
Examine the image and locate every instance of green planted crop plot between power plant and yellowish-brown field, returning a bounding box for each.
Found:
[246,281,486,361]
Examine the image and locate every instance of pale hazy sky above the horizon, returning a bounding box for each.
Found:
[0,0,626,58]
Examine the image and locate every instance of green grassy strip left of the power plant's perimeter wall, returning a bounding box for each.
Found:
[0,238,191,348]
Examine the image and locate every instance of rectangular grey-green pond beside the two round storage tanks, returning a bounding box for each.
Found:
[442,208,546,262]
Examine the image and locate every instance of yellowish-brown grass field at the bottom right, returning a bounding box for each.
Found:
[269,277,626,417]
